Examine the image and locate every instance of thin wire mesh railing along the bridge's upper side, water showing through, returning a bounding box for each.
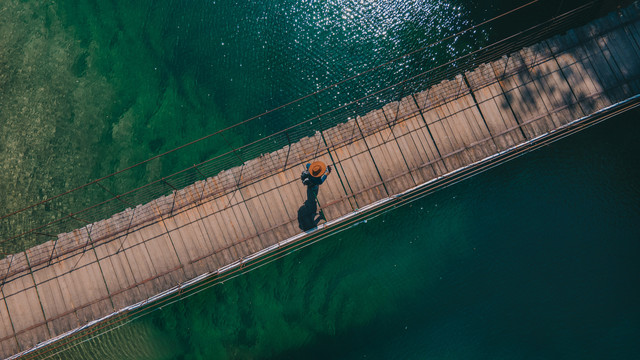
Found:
[0,0,599,255]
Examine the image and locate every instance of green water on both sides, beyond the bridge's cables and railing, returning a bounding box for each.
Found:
[0,0,640,359]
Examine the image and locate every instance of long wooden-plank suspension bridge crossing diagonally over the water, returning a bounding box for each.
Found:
[0,3,640,358]
